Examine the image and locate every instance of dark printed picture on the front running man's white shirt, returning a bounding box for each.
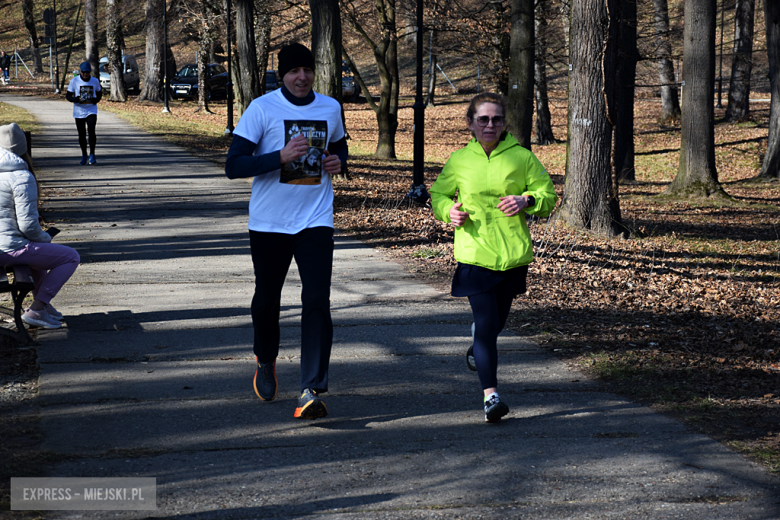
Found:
[279,121,328,185]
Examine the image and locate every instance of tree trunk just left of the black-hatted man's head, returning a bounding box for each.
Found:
[235,0,263,115]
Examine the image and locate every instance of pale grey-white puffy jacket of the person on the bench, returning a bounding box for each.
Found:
[0,148,51,253]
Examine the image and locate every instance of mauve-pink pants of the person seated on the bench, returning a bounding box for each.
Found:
[0,242,81,303]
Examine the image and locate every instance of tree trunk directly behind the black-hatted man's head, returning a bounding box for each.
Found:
[309,0,341,103]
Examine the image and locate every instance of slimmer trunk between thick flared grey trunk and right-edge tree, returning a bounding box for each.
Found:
[726,0,756,122]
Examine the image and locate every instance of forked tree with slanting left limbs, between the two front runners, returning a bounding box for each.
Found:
[342,0,400,159]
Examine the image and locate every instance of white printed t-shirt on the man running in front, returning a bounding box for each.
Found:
[233,89,344,235]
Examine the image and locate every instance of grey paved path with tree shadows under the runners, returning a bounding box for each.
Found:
[0,95,780,520]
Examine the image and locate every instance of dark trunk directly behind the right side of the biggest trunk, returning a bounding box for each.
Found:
[612,0,639,181]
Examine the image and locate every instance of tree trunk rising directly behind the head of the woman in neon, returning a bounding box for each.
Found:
[507,0,535,150]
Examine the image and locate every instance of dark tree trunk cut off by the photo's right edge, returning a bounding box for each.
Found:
[760,0,780,179]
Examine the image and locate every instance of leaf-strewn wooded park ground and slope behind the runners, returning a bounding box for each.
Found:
[0,0,780,471]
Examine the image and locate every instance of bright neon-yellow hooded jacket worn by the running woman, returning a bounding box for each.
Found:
[429,133,558,271]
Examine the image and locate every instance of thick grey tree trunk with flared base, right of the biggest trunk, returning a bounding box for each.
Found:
[666,0,725,197]
